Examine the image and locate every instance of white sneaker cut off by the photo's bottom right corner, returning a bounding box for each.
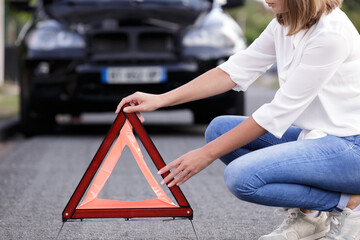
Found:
[322,208,360,240]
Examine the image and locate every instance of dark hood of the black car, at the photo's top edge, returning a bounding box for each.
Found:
[43,0,211,26]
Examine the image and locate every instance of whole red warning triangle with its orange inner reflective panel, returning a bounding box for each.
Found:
[62,105,193,222]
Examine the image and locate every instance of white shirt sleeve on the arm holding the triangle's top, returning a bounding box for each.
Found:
[218,19,277,91]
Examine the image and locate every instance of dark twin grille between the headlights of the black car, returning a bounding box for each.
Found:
[90,27,177,60]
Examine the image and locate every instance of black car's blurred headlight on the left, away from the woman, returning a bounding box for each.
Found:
[27,28,85,51]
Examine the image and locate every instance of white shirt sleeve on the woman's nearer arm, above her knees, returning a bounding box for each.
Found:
[253,32,350,138]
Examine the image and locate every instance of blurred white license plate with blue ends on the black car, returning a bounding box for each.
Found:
[101,67,167,84]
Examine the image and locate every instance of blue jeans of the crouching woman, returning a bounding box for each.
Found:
[205,116,360,211]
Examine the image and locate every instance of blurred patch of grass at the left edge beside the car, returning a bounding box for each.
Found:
[0,82,19,120]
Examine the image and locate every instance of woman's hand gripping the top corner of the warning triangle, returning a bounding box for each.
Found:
[115,92,160,122]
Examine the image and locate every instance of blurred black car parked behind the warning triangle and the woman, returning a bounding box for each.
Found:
[10,0,246,133]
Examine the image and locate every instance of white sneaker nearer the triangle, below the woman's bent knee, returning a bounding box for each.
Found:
[259,208,329,240]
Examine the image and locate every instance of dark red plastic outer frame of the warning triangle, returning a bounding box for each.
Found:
[62,104,193,222]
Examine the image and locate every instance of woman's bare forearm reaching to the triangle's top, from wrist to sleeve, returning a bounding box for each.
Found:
[160,68,236,107]
